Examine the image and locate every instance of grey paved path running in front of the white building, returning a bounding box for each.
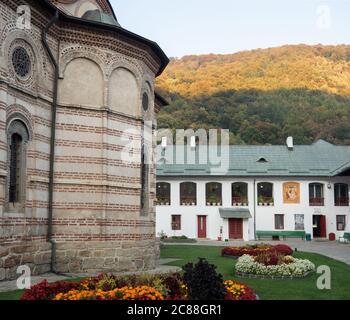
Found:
[165,240,350,265]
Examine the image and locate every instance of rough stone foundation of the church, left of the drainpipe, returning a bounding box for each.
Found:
[0,241,51,281]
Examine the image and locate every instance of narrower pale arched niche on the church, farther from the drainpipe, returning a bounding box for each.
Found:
[108,68,141,117]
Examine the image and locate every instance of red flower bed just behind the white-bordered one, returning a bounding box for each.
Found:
[221,244,293,257]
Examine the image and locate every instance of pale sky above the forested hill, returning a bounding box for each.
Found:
[111,0,350,57]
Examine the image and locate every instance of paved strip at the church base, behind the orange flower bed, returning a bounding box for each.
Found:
[0,259,180,292]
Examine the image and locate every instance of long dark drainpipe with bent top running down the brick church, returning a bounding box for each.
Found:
[42,10,59,272]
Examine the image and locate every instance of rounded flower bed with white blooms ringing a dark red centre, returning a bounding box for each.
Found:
[235,255,316,278]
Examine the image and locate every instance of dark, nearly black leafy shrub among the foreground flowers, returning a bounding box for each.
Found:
[183,259,227,300]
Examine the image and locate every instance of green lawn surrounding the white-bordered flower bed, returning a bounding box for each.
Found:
[161,246,350,300]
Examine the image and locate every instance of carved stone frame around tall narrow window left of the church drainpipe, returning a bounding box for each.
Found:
[5,116,30,213]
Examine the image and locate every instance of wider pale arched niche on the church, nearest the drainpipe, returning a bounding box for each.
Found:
[59,58,104,107]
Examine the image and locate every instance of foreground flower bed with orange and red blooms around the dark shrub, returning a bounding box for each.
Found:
[21,273,256,300]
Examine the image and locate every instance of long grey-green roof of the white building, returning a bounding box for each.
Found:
[157,140,350,177]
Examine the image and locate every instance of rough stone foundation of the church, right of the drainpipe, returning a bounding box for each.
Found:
[55,240,159,274]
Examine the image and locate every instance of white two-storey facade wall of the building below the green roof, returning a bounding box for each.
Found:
[156,177,350,240]
